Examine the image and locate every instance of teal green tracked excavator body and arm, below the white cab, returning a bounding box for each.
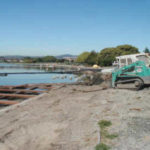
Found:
[112,61,150,90]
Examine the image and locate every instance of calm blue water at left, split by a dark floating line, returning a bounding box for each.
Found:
[0,63,76,85]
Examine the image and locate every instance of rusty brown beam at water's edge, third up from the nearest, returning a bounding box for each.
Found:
[0,89,45,94]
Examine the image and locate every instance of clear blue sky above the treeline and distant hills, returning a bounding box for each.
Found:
[0,0,150,56]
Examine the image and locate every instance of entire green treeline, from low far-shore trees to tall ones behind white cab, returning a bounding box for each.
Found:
[23,45,150,66]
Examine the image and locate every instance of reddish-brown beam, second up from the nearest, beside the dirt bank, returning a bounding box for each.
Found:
[0,93,35,98]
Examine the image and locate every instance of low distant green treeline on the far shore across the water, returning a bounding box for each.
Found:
[23,56,68,63]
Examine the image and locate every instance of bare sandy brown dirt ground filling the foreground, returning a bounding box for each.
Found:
[0,85,150,150]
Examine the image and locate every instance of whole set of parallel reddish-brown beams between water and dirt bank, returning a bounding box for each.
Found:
[0,84,52,106]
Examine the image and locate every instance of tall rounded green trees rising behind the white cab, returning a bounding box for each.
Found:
[76,45,150,66]
